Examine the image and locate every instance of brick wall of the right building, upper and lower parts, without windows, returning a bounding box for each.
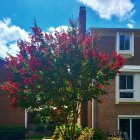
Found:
[87,32,140,134]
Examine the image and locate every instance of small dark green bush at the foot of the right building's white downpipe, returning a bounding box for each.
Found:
[93,129,107,140]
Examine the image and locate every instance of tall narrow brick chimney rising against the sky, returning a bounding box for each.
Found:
[79,6,86,35]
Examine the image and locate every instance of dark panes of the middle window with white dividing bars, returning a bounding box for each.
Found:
[119,75,134,98]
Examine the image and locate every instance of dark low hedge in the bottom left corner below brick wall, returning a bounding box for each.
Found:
[0,126,27,140]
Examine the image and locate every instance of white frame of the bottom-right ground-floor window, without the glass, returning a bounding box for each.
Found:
[118,115,140,140]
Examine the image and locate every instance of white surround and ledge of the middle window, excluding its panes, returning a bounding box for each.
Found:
[115,65,140,104]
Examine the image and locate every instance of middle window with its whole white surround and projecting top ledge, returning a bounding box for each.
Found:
[115,65,140,104]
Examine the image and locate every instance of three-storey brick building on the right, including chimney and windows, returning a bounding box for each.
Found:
[79,7,140,140]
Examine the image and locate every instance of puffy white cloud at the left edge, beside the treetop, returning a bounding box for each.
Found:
[0,18,28,58]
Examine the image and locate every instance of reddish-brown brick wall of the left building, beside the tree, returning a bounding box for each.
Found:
[0,59,25,126]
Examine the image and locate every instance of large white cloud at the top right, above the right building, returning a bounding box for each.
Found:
[78,0,135,20]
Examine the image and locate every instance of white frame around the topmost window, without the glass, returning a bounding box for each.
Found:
[116,32,134,58]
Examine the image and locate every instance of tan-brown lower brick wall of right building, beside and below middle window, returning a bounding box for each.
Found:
[94,81,140,134]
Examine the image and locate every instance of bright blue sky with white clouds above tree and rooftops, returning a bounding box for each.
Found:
[0,0,140,57]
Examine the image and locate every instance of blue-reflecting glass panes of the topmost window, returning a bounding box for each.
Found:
[119,34,131,51]
